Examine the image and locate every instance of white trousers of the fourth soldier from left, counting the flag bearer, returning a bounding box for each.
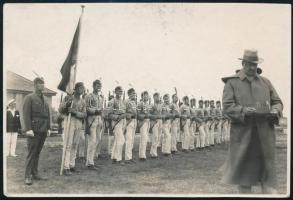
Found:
[125,119,136,160]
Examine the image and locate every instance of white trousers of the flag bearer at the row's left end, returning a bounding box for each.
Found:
[63,117,84,169]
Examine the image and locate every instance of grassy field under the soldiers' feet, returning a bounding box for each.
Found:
[6,132,287,195]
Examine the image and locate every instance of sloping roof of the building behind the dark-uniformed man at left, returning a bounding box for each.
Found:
[6,71,57,96]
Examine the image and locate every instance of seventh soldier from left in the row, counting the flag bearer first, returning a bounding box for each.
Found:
[162,94,173,156]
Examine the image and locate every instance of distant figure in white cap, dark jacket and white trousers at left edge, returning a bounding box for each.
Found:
[6,99,21,157]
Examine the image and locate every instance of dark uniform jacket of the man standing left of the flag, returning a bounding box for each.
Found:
[23,93,51,132]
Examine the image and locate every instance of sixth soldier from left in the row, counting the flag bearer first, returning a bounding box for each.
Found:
[150,92,162,158]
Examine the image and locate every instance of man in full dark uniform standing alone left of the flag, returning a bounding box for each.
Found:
[23,77,50,185]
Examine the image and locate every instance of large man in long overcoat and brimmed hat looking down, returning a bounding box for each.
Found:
[222,50,283,193]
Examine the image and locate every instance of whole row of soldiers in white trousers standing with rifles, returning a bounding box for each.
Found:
[59,80,230,175]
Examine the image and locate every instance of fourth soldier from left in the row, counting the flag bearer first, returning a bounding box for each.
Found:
[125,88,137,163]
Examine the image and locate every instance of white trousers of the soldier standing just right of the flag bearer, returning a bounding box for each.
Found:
[86,116,103,166]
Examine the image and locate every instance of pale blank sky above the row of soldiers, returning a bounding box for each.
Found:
[3,3,291,117]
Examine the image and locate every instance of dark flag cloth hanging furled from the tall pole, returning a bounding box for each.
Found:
[58,18,80,93]
